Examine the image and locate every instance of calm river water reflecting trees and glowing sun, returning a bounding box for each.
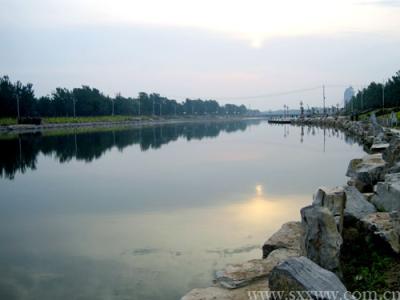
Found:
[0,120,363,300]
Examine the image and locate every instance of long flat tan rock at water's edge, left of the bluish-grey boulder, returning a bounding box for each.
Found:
[216,248,299,289]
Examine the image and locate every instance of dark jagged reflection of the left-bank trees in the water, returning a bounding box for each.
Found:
[0,120,261,179]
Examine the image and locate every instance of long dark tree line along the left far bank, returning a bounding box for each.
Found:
[0,76,254,117]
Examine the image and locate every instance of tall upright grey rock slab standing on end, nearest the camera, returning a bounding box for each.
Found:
[301,205,343,274]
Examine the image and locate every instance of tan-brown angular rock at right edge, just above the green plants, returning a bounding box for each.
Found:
[361,212,400,253]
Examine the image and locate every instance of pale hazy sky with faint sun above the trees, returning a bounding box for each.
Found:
[0,0,400,110]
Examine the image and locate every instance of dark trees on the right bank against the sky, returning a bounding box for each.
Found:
[345,71,400,112]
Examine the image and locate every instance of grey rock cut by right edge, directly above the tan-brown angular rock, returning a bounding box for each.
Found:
[371,173,400,211]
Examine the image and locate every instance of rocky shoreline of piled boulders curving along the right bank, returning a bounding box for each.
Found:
[182,118,400,300]
